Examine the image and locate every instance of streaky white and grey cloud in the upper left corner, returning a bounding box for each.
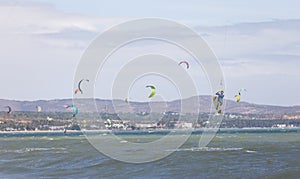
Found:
[0,2,126,48]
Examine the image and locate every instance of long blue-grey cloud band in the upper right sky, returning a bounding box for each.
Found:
[196,20,300,58]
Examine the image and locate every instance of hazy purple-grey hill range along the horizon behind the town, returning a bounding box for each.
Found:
[0,95,300,114]
